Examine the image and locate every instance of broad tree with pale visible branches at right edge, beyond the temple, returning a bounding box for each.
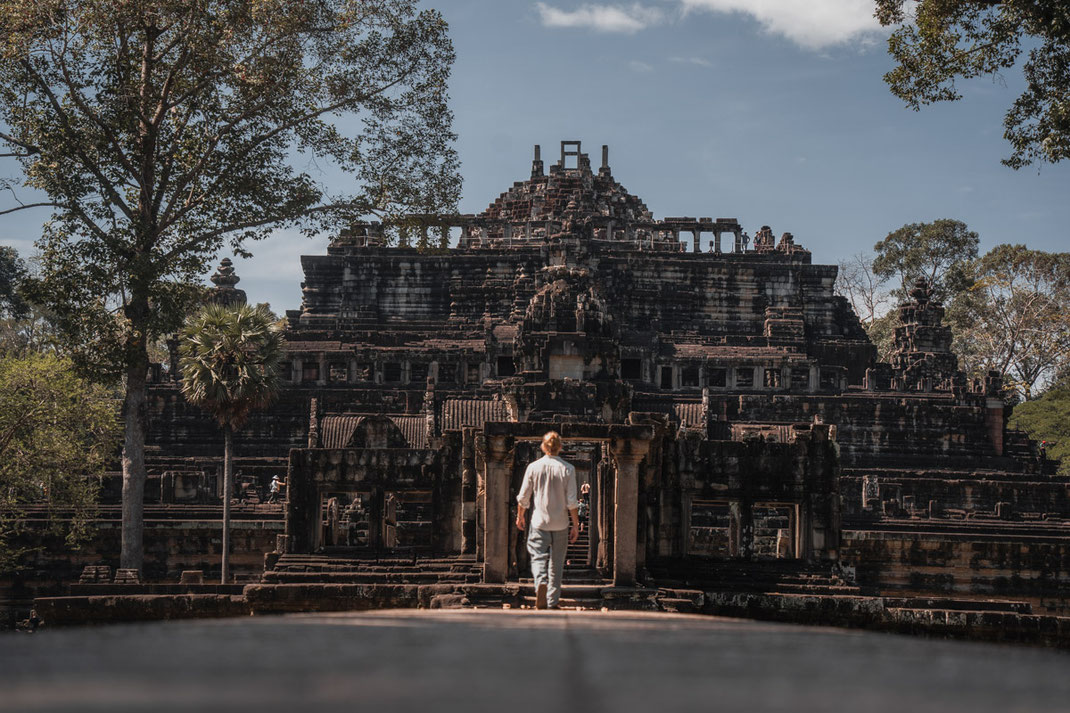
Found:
[948,245,1070,400]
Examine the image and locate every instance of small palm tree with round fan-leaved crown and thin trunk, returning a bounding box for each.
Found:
[179,304,282,583]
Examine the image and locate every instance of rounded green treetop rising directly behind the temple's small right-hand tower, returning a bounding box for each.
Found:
[873,218,979,302]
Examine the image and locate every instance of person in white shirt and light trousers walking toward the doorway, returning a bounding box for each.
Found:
[517,430,580,609]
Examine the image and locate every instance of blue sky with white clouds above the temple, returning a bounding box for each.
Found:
[0,0,1070,312]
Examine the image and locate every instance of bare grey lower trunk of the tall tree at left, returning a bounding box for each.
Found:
[119,340,149,572]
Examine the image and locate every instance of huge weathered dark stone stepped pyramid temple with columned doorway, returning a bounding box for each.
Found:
[10,141,1070,625]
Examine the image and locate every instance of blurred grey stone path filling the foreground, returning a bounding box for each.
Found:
[0,610,1070,713]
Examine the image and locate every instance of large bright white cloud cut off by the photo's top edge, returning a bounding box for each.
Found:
[679,0,881,49]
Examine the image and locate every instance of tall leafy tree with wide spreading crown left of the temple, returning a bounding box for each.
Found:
[0,0,459,567]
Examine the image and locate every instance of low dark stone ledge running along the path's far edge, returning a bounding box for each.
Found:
[34,583,1070,649]
